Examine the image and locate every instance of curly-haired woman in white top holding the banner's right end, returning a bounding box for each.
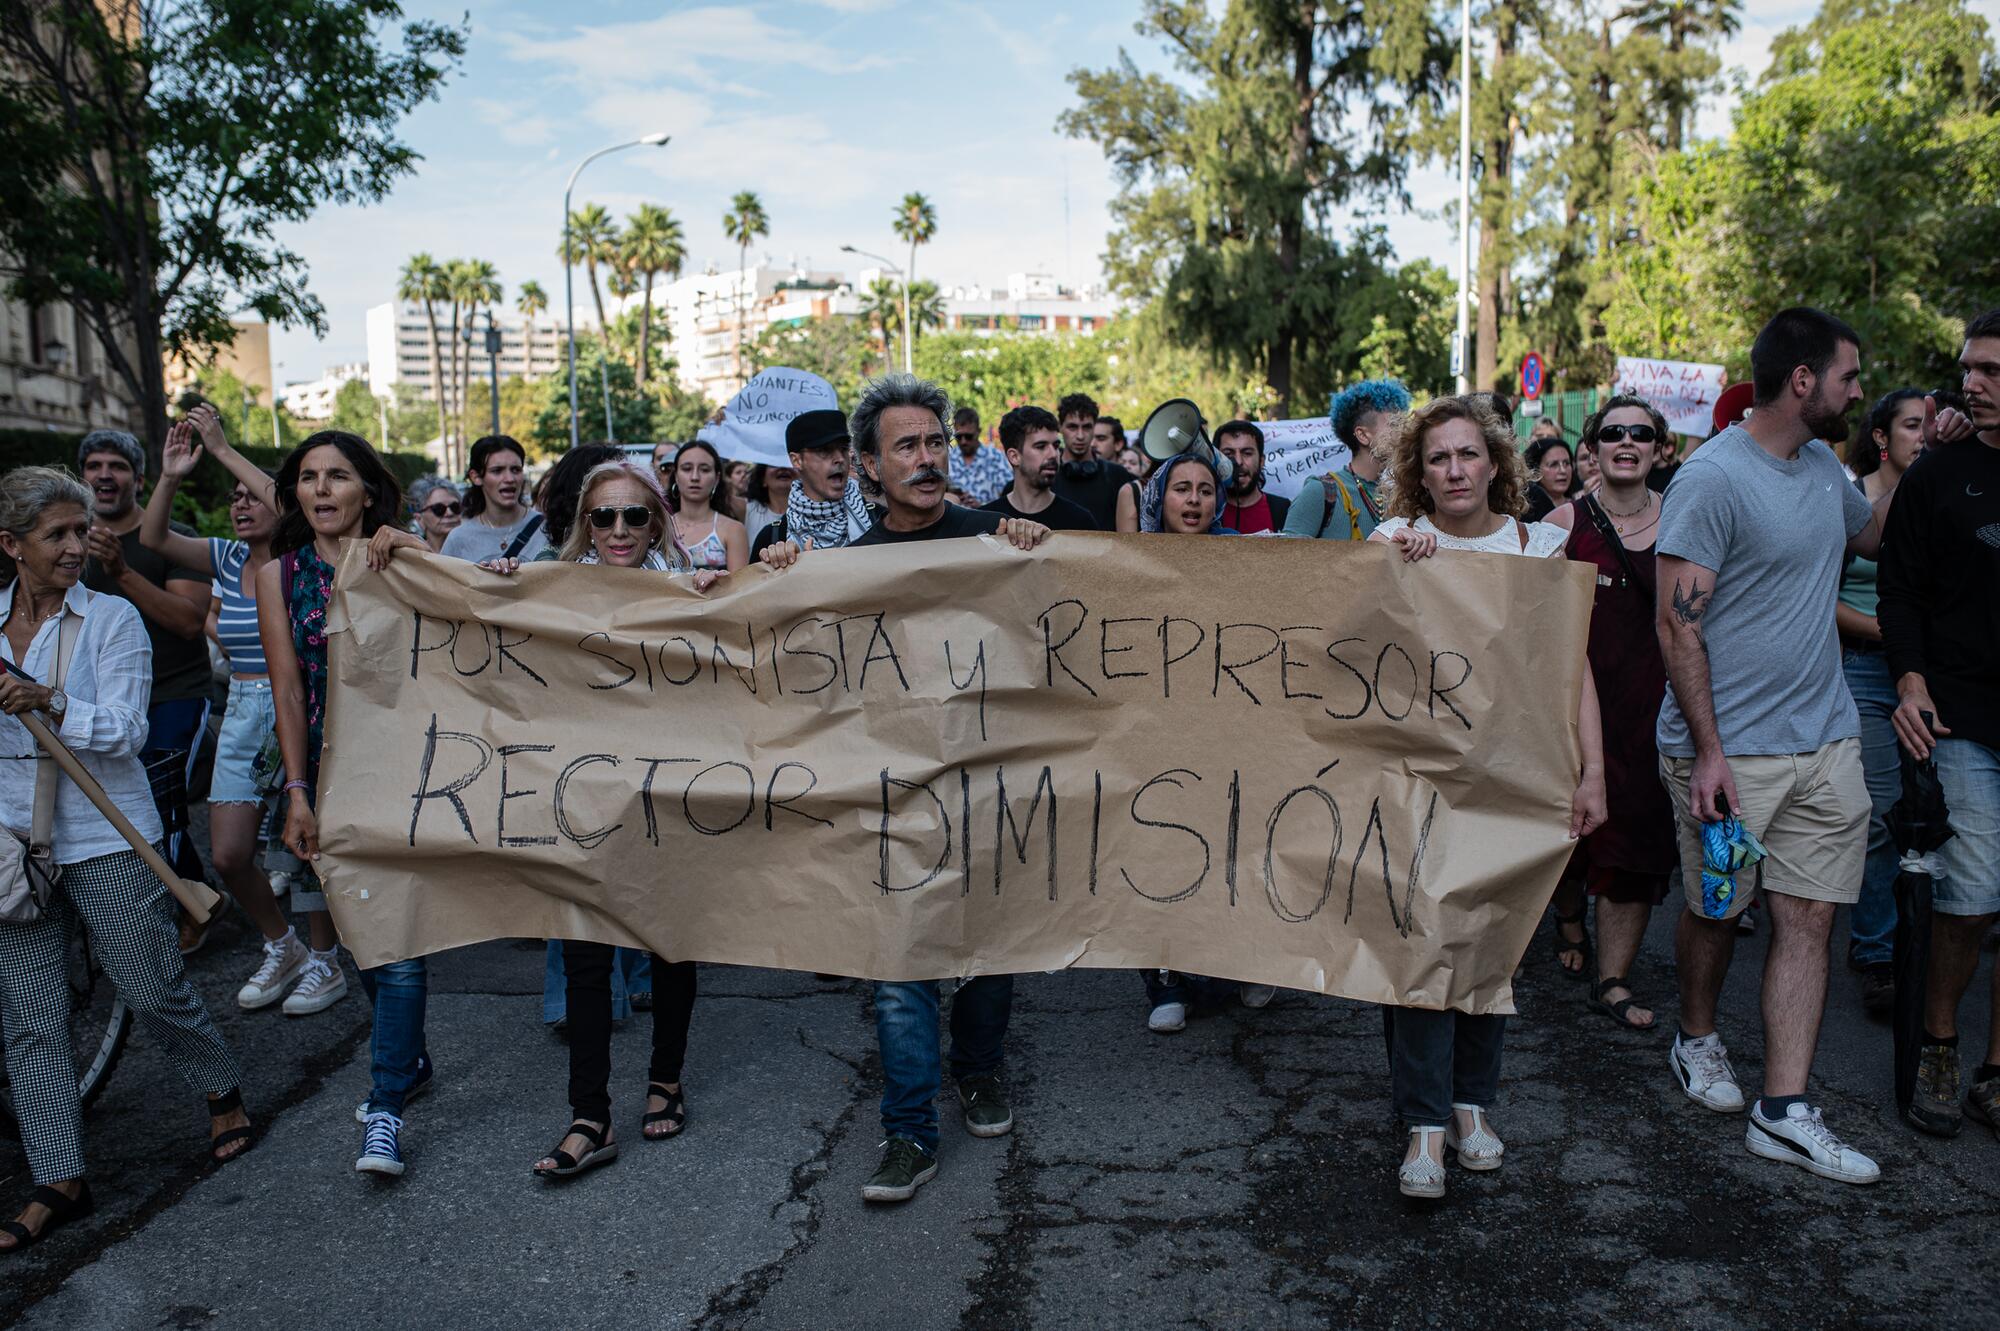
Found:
[1368,398,1604,1197]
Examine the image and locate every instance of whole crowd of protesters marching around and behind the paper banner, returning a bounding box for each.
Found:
[0,295,2000,1251]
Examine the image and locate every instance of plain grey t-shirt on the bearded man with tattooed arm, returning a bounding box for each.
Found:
[1658,426,1870,757]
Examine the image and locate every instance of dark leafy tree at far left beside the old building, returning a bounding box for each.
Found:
[0,0,466,450]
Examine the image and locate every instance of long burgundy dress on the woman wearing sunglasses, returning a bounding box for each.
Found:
[1566,504,1678,891]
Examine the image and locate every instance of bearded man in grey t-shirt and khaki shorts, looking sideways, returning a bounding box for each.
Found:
[1656,308,1888,1183]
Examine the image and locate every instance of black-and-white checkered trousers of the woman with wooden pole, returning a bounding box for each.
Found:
[0,851,242,1183]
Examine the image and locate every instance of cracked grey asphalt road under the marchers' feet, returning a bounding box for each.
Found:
[0,867,2000,1331]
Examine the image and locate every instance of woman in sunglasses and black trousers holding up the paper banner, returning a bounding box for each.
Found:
[480,460,720,1179]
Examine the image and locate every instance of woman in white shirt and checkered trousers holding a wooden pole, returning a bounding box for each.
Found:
[0,468,252,1253]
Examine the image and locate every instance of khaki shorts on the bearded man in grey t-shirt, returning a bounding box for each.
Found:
[1660,739,1872,917]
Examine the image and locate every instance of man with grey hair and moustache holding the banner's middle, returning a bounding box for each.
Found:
[764,374,1056,1201]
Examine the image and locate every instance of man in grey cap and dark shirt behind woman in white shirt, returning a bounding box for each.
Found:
[76,430,210,923]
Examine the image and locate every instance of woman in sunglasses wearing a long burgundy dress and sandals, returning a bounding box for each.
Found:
[1548,398,1676,1031]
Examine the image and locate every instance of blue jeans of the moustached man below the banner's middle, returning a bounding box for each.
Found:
[876,975,1014,1151]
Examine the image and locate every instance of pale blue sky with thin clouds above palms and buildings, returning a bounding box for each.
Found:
[272,0,2000,382]
